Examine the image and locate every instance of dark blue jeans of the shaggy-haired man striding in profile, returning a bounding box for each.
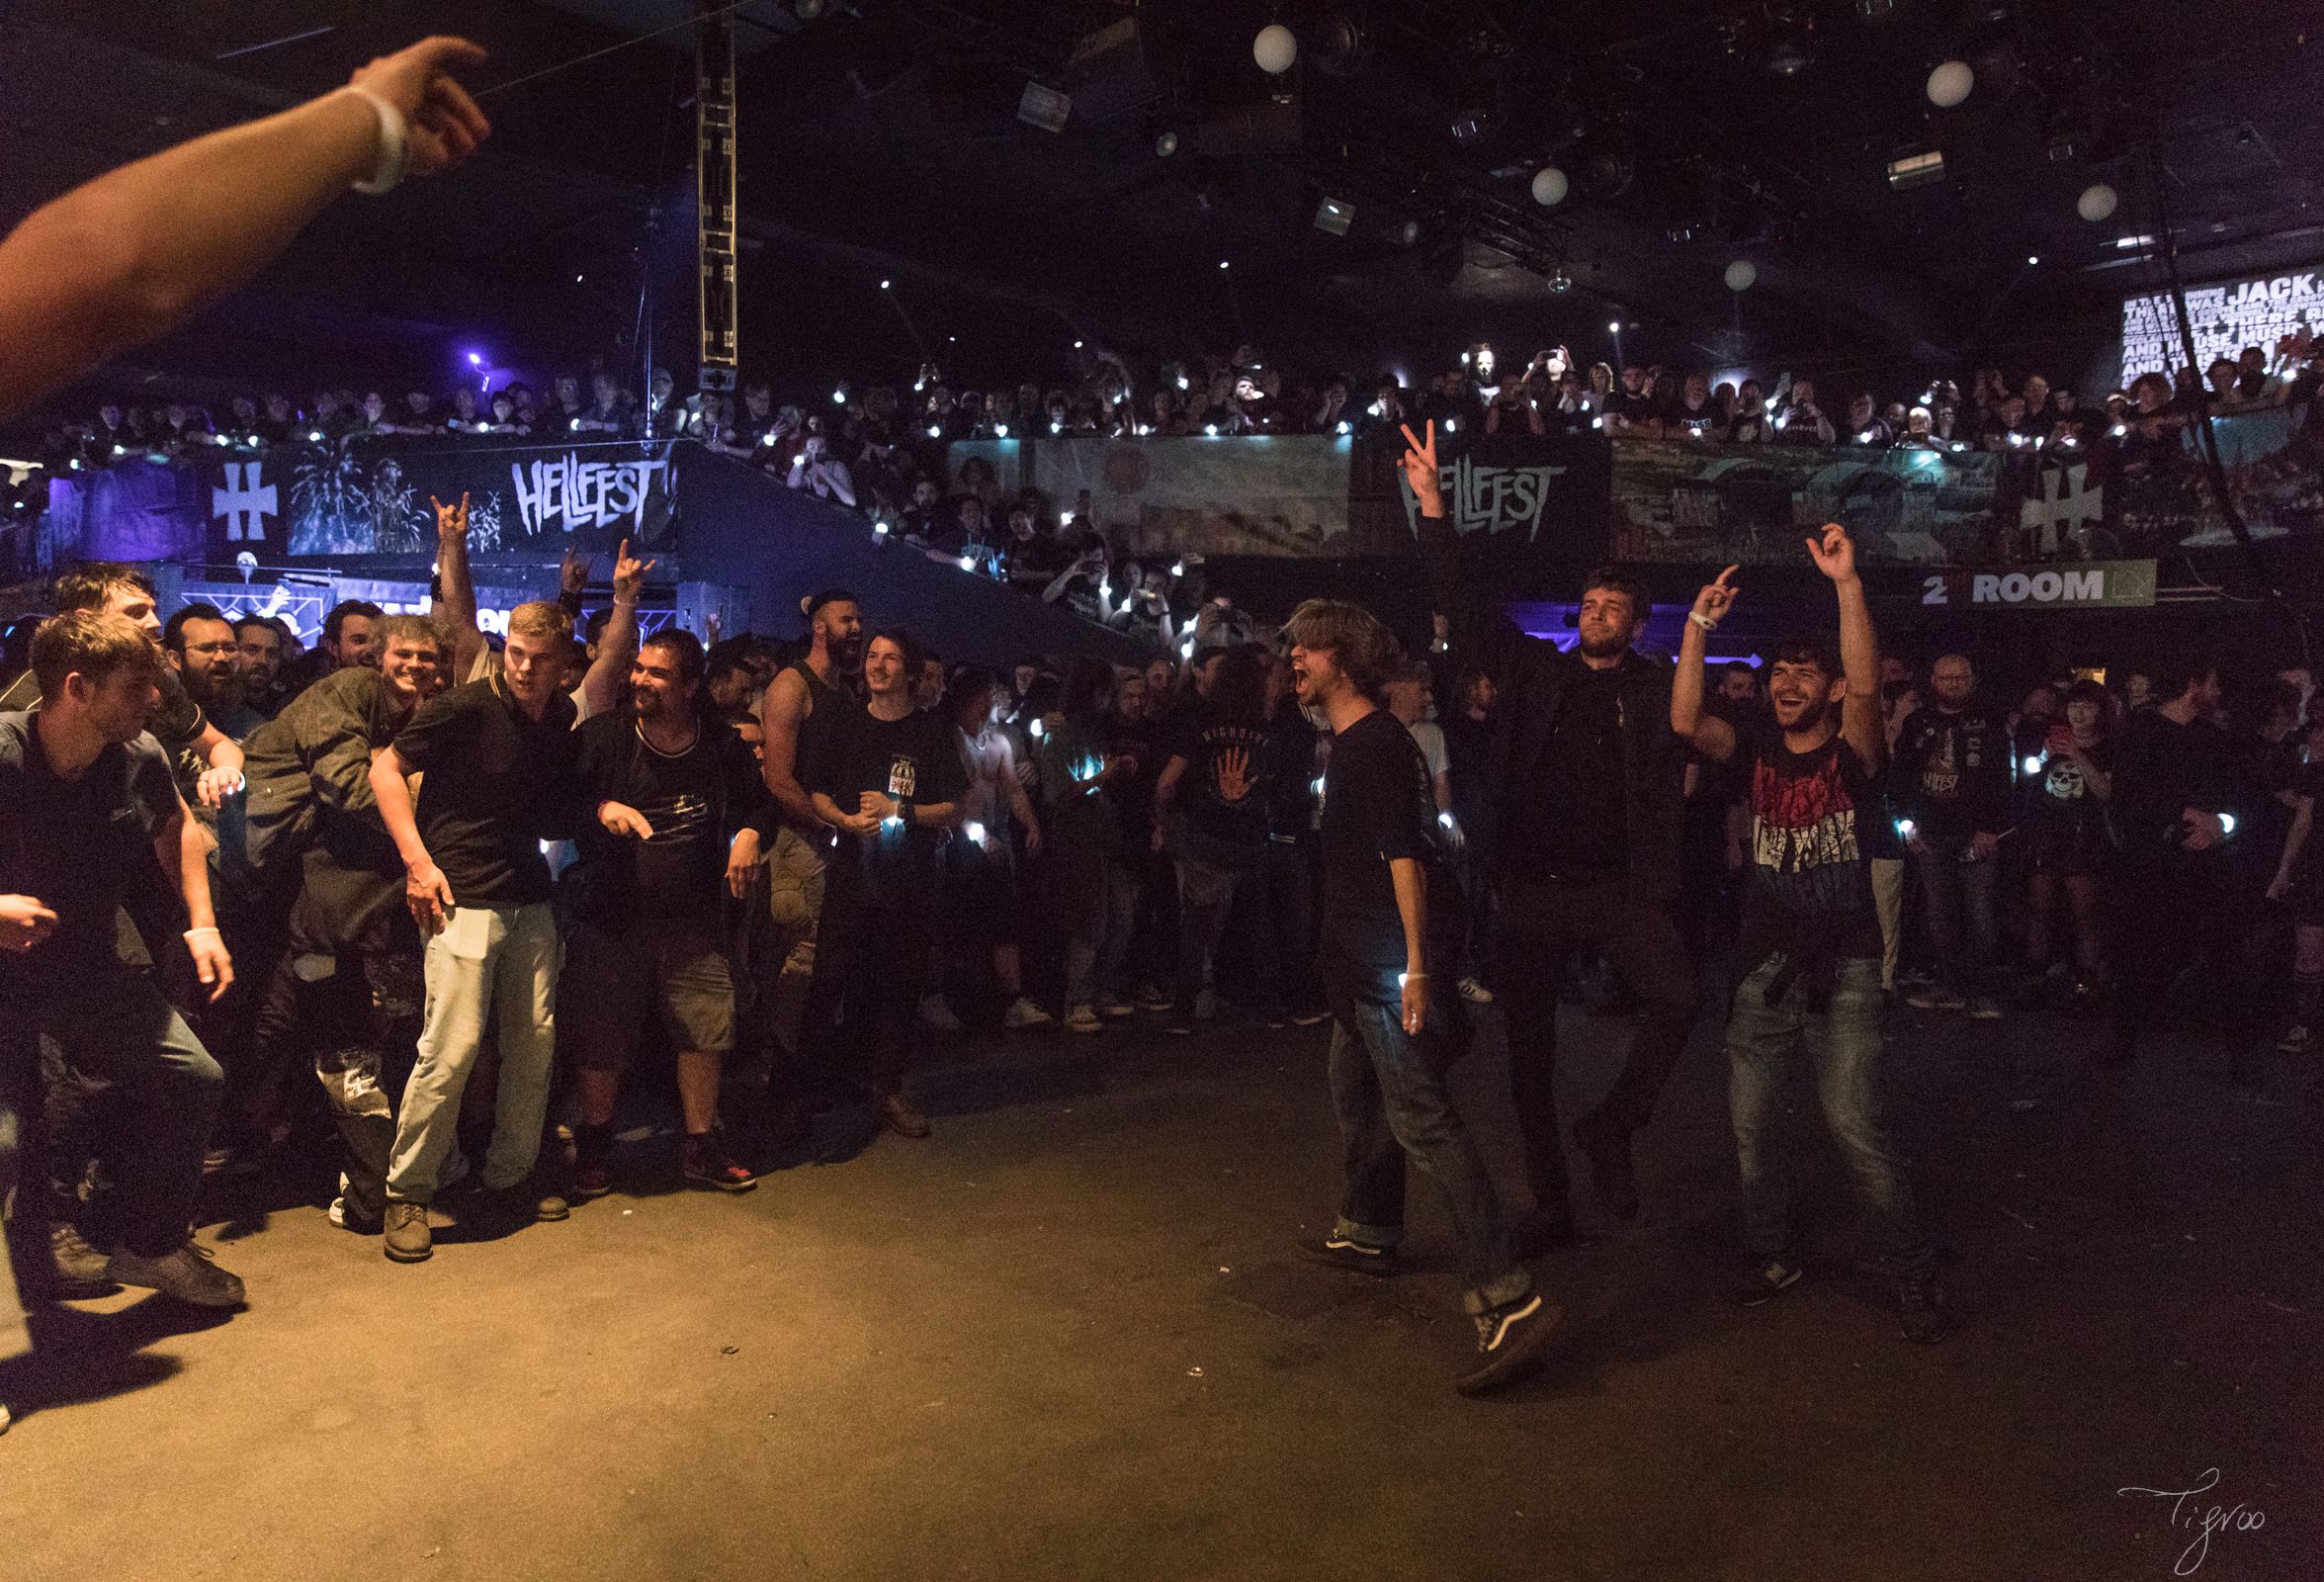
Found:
[1332,999,1534,1312]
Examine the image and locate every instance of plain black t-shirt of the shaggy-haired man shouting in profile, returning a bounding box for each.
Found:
[1320,709,1436,995]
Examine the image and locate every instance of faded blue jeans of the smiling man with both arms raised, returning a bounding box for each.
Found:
[1727,952,1936,1275]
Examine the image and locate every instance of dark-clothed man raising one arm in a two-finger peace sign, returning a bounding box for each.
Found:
[1404,427,1696,1250]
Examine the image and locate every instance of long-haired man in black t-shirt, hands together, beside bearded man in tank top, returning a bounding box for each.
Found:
[800,630,967,1138]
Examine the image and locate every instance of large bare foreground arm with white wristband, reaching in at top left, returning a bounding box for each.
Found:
[0,38,492,418]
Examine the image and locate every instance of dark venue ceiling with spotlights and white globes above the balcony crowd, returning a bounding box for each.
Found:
[0,0,2324,403]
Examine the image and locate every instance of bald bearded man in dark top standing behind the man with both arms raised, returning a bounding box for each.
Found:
[1889,653,2011,1019]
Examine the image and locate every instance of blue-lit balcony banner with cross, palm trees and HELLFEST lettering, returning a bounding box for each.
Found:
[191,439,676,558]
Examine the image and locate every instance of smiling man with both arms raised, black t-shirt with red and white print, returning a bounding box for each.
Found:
[1671,523,1947,1341]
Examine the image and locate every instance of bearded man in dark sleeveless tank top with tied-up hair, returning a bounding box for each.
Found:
[757,587,865,1131]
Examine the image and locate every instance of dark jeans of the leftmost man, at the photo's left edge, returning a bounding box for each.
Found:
[0,966,225,1264]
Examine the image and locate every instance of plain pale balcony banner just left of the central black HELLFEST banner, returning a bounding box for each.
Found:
[1025,434,1378,556]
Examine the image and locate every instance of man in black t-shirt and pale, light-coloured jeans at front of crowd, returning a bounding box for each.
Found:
[370,602,583,1264]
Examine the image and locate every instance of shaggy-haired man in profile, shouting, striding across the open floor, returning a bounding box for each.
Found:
[1283,599,1562,1394]
